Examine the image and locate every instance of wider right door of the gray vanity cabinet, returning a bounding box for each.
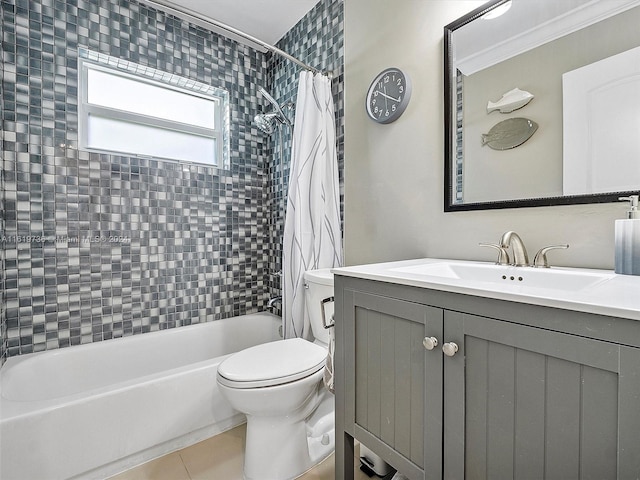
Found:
[444,312,640,480]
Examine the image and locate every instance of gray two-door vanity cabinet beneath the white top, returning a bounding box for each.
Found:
[336,275,640,480]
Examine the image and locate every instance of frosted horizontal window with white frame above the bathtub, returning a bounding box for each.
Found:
[79,49,229,166]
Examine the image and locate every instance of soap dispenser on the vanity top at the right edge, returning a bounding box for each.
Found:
[615,195,640,275]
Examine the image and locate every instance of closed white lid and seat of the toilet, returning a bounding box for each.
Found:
[218,338,327,388]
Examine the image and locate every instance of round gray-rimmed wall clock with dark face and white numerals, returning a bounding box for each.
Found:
[365,68,411,123]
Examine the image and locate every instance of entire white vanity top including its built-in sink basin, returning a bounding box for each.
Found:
[332,258,640,321]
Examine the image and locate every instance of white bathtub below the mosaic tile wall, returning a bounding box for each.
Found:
[0,313,281,480]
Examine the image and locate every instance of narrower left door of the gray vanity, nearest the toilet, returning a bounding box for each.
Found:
[344,291,443,480]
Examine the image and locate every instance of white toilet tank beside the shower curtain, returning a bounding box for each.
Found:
[304,268,334,345]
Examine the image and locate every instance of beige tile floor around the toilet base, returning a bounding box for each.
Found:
[110,425,369,480]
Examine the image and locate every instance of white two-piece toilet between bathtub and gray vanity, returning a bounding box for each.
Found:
[217,269,335,480]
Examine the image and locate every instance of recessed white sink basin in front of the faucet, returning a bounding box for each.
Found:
[390,261,615,291]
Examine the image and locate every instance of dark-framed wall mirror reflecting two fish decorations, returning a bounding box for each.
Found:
[444,0,640,211]
